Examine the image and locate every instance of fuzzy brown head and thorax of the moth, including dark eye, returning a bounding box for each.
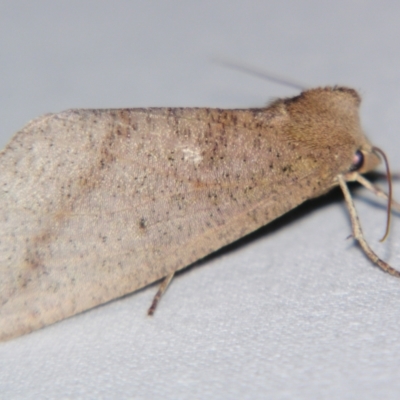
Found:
[283,86,380,173]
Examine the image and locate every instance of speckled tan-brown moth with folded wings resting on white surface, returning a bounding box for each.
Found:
[0,87,400,341]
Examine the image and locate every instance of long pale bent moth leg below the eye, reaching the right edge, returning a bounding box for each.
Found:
[337,175,400,278]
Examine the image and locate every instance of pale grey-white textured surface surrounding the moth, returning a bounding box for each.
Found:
[0,0,400,399]
